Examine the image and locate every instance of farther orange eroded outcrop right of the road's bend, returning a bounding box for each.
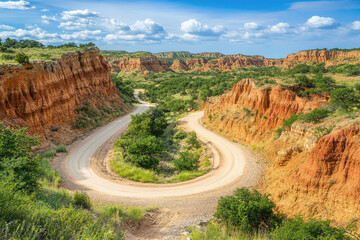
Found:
[205,79,322,143]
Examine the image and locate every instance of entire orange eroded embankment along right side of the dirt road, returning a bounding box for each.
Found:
[204,79,360,223]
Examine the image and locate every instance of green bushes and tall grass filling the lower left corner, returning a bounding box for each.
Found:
[0,124,158,239]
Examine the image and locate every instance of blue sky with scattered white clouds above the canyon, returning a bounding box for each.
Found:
[0,0,360,58]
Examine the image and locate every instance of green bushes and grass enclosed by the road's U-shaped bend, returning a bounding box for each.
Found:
[111,108,211,183]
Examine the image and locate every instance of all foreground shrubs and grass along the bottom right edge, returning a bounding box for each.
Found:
[190,188,360,240]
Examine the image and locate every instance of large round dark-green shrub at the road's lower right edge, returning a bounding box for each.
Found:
[214,188,281,232]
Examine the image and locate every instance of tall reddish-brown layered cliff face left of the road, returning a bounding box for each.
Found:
[0,50,122,145]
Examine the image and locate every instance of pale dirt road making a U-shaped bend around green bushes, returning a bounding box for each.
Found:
[60,103,260,239]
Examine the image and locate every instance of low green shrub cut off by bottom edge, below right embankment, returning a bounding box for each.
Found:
[271,217,350,240]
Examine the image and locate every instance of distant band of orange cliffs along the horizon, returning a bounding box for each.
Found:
[106,50,360,72]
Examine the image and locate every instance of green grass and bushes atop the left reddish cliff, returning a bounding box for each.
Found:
[0,38,96,65]
